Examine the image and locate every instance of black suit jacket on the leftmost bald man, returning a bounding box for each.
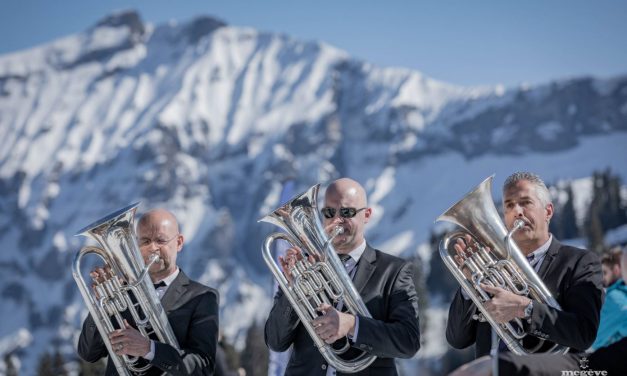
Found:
[78,270,219,375]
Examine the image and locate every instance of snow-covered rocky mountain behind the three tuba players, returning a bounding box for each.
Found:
[0,12,627,370]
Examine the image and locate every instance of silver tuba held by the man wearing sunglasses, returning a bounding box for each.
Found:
[259,184,376,373]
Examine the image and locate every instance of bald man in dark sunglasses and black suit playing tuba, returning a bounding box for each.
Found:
[265,178,420,376]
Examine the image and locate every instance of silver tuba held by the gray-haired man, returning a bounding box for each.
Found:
[436,175,569,355]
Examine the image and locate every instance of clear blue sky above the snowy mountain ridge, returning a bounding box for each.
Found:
[0,0,627,86]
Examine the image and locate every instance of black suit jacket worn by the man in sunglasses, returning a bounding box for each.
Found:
[265,245,420,376]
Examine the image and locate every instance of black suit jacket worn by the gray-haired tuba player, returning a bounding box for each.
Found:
[446,237,604,357]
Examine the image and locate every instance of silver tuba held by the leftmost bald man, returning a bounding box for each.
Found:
[72,203,179,376]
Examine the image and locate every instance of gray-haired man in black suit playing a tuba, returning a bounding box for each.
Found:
[446,172,603,357]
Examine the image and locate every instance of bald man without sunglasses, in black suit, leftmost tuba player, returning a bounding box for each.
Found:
[78,209,219,375]
